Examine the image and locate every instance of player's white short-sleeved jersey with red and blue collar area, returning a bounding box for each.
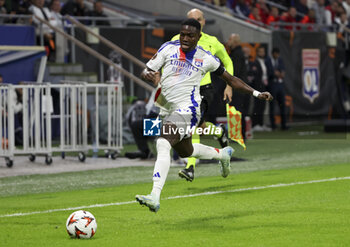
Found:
[146,40,220,111]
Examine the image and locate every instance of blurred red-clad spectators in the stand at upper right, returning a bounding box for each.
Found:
[204,0,350,30]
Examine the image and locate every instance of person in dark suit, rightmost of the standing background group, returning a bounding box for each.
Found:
[266,47,288,130]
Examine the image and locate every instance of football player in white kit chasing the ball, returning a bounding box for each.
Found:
[136,19,272,212]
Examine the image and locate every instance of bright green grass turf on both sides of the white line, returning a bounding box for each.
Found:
[0,164,350,246]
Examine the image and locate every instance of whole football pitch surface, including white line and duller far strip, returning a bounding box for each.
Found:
[0,128,350,246]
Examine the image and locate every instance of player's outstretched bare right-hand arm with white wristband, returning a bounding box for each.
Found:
[220,71,273,101]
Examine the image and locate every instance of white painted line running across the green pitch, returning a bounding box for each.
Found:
[0,177,350,218]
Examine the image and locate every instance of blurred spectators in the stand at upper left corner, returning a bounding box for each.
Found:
[0,0,110,61]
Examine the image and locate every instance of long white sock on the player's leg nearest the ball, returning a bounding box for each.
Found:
[152,137,171,200]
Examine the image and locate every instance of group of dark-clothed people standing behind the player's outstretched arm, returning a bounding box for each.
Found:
[226,34,289,133]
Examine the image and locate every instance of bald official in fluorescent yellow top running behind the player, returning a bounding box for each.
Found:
[172,9,233,181]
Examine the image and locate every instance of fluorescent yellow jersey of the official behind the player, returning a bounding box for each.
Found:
[171,32,233,86]
